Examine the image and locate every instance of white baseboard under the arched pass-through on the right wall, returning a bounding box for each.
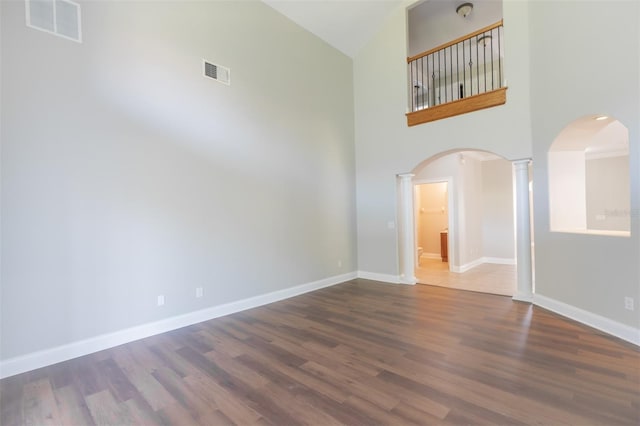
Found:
[533,294,640,346]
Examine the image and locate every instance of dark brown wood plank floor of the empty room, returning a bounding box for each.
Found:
[0,280,640,426]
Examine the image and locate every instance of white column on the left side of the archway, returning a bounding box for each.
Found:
[398,173,416,284]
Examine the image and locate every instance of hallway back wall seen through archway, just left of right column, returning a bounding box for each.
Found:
[481,159,516,262]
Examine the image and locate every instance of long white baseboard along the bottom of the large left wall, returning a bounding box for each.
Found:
[0,272,358,378]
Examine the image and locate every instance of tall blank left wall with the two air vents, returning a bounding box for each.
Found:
[0,1,357,360]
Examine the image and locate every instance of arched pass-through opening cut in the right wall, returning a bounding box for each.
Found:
[548,115,631,237]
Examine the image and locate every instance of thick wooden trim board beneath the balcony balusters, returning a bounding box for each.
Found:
[406,87,507,127]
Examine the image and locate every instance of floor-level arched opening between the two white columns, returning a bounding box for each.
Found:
[412,150,516,296]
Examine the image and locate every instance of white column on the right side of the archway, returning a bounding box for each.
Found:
[513,159,533,302]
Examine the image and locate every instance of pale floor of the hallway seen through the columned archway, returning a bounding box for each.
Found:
[415,259,516,296]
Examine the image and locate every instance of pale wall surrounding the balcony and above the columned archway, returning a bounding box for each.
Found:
[354,2,531,275]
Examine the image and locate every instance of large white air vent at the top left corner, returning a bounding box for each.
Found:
[25,0,82,43]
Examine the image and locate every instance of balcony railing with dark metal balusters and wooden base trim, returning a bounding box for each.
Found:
[407,21,506,126]
